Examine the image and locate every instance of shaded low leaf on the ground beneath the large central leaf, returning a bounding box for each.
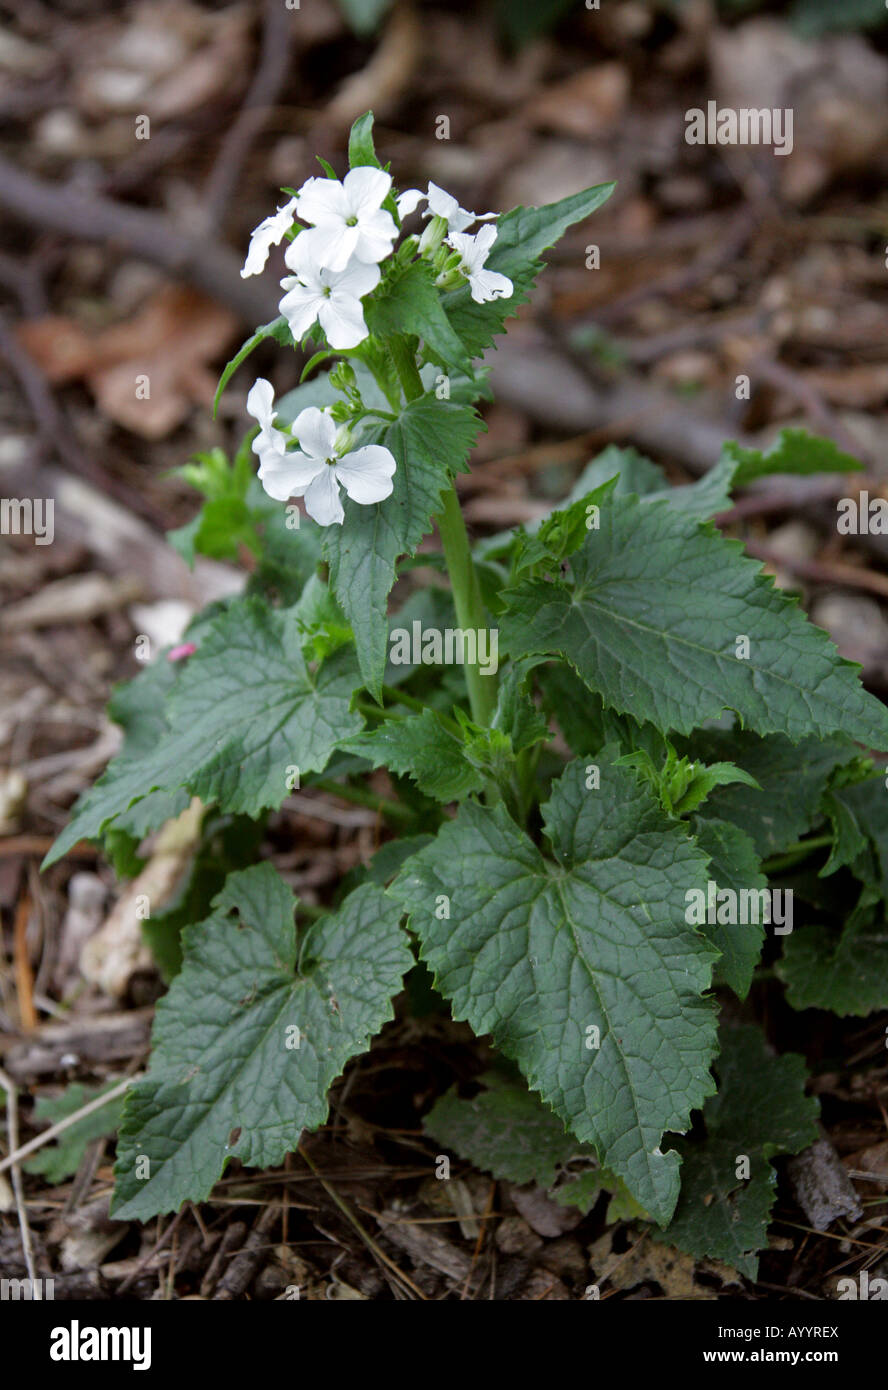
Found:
[422,1072,628,1212]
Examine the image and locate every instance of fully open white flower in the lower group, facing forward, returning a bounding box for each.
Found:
[260,406,397,525]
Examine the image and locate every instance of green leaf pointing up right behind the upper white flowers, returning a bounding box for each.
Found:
[443,183,614,357]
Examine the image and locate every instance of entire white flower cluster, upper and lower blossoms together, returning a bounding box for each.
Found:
[240,165,513,525]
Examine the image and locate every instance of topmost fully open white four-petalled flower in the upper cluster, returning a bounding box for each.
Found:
[297,165,397,270]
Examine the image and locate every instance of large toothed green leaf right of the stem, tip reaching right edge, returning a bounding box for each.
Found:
[500,496,888,746]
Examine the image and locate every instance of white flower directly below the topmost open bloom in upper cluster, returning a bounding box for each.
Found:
[279,232,381,352]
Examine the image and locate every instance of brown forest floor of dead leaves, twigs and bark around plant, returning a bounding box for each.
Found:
[0,0,888,1300]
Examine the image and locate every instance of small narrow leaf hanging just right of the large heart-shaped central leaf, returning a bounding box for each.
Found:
[693,820,767,999]
